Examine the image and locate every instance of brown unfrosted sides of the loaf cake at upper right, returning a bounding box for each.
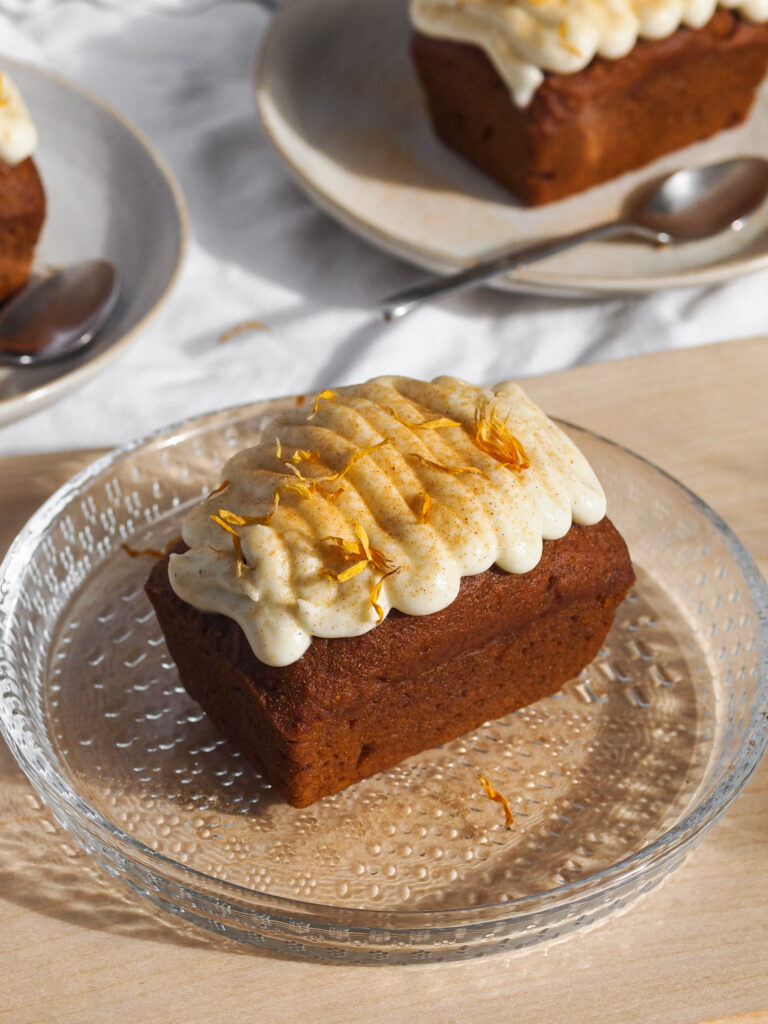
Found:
[412,8,768,205]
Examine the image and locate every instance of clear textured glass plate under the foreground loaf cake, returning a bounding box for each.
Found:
[0,398,768,963]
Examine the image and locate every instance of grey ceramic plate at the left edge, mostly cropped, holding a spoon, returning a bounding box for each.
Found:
[0,58,186,425]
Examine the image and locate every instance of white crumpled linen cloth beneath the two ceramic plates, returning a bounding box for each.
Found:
[0,0,768,455]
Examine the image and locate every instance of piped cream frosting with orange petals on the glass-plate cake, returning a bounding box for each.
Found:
[169,377,605,666]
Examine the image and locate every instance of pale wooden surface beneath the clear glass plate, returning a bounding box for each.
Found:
[0,339,768,1024]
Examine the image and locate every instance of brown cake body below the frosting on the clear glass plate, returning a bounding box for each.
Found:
[146,519,634,807]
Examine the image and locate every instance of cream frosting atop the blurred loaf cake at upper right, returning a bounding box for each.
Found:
[411,0,768,106]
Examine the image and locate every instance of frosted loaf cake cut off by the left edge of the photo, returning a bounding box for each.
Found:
[0,74,45,302]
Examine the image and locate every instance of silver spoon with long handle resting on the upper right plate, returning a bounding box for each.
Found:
[381,157,768,321]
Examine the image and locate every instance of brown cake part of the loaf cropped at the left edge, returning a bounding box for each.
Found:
[0,157,45,302]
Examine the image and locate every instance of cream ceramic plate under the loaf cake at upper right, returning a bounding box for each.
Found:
[256,0,768,294]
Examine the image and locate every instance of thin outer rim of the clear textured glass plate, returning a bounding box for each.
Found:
[0,395,768,932]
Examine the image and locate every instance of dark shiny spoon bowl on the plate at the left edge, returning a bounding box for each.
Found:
[0,259,120,367]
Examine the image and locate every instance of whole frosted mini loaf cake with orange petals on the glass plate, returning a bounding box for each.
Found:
[147,377,634,807]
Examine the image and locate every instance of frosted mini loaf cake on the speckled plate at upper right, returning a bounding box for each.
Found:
[411,0,768,205]
